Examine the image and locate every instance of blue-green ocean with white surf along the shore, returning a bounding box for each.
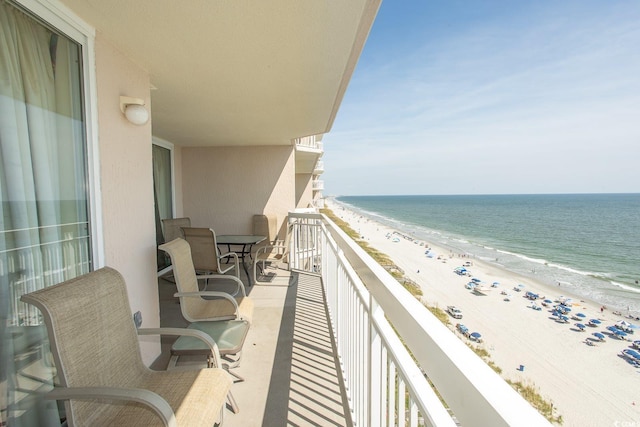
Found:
[336,194,640,316]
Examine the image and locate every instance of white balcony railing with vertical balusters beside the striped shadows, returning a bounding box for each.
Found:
[289,213,550,427]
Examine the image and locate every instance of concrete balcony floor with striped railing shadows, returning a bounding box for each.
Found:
[153,269,352,427]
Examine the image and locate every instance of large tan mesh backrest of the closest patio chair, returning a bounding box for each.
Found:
[21,267,148,425]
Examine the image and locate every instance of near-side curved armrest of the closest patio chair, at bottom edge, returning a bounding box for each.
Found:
[45,387,178,427]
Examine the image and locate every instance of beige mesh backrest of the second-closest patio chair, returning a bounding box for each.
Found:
[159,239,220,320]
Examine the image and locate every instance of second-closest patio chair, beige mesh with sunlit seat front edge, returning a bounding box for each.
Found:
[159,239,253,323]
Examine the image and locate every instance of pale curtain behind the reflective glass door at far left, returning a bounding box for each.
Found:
[0,2,90,426]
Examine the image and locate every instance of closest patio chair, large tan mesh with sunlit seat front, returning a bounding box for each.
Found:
[21,268,232,426]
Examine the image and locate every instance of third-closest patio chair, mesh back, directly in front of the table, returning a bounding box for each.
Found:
[182,227,240,280]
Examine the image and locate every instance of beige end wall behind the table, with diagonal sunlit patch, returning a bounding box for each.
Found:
[181,146,296,234]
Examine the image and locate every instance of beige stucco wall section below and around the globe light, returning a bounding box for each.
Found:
[95,32,160,363]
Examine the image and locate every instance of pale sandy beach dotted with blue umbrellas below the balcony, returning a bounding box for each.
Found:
[327,200,640,427]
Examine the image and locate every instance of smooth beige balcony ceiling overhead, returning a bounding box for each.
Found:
[62,0,381,146]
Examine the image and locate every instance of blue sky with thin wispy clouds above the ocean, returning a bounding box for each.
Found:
[321,0,640,196]
